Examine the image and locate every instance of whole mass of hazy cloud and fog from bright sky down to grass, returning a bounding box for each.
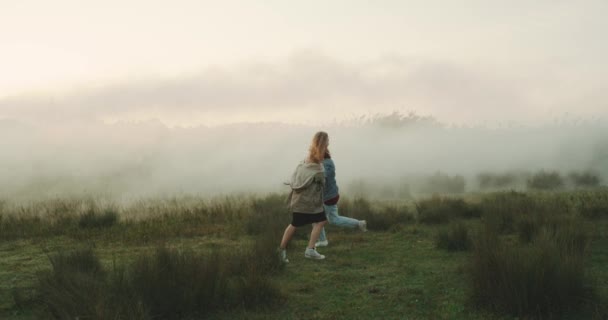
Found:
[0,50,608,200]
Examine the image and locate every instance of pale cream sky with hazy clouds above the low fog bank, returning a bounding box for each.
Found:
[0,0,608,125]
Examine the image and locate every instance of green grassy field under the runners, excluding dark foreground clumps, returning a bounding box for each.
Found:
[0,190,608,319]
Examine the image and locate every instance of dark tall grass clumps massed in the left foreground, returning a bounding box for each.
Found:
[37,235,283,319]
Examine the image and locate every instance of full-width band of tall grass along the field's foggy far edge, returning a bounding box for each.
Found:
[0,188,608,243]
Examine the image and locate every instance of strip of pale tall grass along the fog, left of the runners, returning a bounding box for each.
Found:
[0,194,289,243]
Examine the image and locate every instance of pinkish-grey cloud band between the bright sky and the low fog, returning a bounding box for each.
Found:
[0,50,608,126]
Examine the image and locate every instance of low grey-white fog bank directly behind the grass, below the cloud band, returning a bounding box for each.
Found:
[0,113,608,200]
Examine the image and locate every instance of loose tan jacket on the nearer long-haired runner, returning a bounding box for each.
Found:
[289,162,325,214]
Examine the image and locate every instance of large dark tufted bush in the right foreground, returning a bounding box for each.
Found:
[468,224,593,317]
